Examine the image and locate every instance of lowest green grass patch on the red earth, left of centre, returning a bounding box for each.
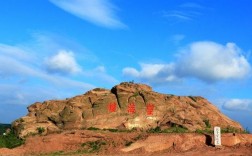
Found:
[81,140,106,153]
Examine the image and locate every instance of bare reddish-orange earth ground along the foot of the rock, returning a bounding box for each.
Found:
[0,130,252,156]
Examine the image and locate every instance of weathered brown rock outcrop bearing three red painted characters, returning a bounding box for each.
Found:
[12,83,242,137]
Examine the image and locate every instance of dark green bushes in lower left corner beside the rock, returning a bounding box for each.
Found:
[0,130,24,148]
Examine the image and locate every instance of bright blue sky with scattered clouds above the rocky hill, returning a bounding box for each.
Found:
[0,0,252,131]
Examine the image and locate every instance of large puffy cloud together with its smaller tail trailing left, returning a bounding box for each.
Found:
[122,42,251,84]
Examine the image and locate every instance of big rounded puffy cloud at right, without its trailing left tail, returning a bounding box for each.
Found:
[176,42,251,82]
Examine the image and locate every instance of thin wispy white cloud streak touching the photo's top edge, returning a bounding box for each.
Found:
[50,0,126,28]
